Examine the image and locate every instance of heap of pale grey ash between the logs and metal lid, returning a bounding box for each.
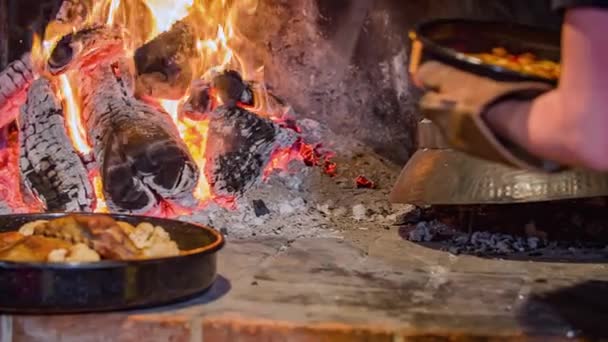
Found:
[180,120,411,239]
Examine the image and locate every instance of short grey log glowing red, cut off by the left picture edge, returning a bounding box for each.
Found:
[0,53,34,127]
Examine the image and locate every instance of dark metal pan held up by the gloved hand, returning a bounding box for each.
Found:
[410,19,560,85]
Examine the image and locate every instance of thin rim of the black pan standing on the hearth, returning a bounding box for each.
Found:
[0,212,226,270]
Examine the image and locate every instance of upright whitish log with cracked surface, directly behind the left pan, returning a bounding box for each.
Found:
[19,78,95,212]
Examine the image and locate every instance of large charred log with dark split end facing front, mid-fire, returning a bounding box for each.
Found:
[81,59,198,212]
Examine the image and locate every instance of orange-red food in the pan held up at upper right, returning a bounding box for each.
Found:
[468,47,560,80]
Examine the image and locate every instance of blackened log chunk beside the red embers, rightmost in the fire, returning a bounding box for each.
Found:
[205,106,296,196]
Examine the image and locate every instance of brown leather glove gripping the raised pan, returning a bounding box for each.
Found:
[414,61,558,171]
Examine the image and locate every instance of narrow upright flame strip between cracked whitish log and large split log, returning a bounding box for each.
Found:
[59,74,92,155]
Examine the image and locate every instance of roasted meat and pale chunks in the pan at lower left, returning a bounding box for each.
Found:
[0,215,180,262]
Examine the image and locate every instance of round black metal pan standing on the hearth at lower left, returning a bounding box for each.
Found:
[0,214,224,314]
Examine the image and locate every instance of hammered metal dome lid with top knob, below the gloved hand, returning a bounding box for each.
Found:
[389,120,608,205]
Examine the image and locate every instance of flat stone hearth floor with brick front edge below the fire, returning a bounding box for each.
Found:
[5,228,608,342]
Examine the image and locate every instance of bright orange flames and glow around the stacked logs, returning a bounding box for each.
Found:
[17,0,320,216]
